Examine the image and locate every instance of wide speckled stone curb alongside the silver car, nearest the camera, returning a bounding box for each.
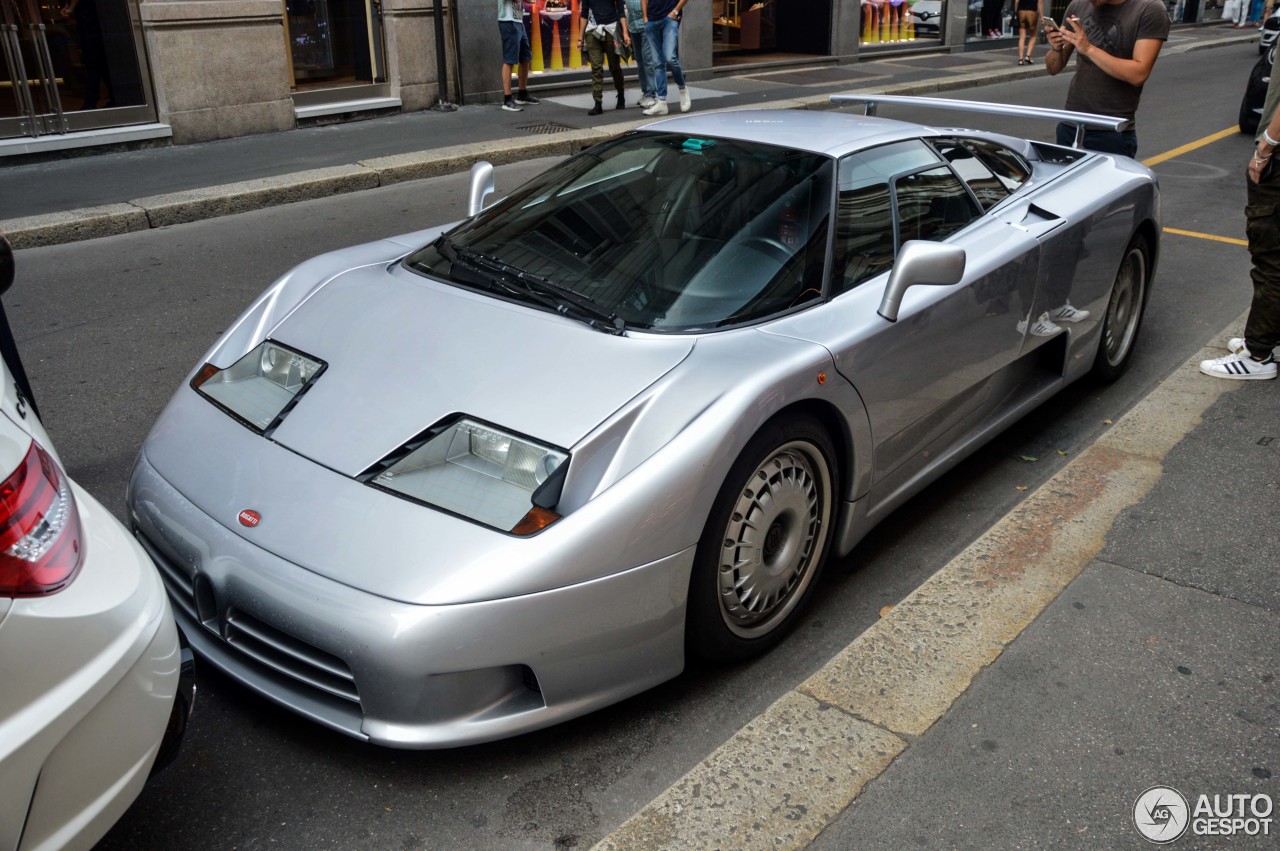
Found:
[595,316,1244,851]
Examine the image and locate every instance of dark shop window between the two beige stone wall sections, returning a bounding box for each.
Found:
[284,0,387,91]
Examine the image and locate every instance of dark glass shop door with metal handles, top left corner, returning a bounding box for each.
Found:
[0,0,155,138]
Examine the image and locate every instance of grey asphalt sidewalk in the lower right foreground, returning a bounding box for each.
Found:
[812,317,1280,851]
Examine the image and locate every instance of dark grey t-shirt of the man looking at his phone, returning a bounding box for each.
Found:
[1064,0,1169,120]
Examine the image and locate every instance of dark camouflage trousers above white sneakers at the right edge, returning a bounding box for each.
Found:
[1244,170,1280,356]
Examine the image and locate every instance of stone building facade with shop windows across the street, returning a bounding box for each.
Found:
[0,0,1039,155]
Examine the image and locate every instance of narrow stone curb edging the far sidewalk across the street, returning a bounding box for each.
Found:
[0,33,1257,250]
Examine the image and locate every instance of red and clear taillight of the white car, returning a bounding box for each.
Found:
[0,441,81,596]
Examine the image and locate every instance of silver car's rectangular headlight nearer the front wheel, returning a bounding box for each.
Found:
[370,417,568,535]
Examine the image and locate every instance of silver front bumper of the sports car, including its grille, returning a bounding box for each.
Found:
[129,456,692,749]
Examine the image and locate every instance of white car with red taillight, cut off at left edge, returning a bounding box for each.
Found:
[0,235,195,851]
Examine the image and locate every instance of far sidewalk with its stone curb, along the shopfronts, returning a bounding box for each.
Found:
[0,22,1258,248]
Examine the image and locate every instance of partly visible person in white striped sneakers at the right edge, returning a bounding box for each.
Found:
[1201,74,1280,380]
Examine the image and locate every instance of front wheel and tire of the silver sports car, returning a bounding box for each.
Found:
[685,416,838,662]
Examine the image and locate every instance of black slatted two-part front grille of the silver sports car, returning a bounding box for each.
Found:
[134,530,360,709]
